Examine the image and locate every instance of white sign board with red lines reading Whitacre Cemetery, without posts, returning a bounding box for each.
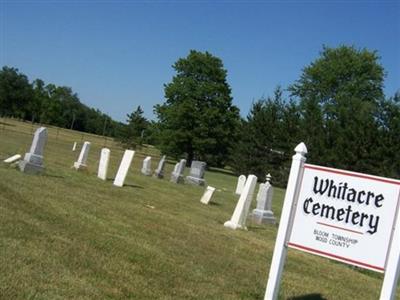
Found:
[288,164,400,272]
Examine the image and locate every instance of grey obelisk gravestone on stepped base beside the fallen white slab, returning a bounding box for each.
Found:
[19,127,47,174]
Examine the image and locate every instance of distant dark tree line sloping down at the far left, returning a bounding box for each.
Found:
[0,66,124,136]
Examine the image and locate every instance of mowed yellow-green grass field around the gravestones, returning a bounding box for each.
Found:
[0,119,399,299]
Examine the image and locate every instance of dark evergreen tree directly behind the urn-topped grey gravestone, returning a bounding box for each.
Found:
[231,87,300,186]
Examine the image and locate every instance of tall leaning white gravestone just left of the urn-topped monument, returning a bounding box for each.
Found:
[224,175,257,229]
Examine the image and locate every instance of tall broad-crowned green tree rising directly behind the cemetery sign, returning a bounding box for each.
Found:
[289,46,385,172]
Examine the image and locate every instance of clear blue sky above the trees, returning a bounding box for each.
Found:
[0,0,400,121]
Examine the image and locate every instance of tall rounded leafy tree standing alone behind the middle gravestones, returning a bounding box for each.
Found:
[155,50,240,166]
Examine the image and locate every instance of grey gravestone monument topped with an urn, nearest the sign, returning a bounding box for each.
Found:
[251,174,276,224]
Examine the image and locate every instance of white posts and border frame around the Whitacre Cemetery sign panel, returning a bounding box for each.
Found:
[264,143,400,300]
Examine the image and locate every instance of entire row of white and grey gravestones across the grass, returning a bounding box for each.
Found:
[5,127,275,229]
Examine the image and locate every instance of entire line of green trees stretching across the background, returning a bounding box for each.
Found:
[0,46,400,186]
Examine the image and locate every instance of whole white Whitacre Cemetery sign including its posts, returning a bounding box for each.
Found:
[265,143,400,300]
